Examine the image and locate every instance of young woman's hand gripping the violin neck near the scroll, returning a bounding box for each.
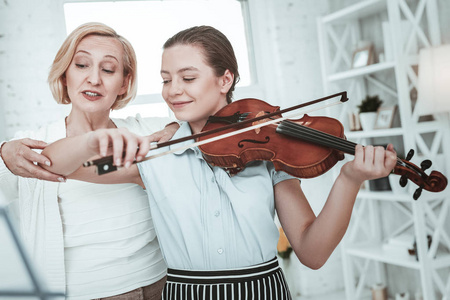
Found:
[341,144,397,184]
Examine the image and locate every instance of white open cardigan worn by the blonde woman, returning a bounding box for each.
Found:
[0,115,171,293]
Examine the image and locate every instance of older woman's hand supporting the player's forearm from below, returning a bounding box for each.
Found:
[0,138,64,182]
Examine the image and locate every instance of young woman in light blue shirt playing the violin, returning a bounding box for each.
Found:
[40,26,397,299]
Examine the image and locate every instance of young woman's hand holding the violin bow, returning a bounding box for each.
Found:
[88,128,150,168]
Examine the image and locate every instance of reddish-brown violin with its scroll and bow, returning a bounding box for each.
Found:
[84,92,447,200]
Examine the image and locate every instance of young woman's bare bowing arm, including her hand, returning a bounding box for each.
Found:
[43,128,150,186]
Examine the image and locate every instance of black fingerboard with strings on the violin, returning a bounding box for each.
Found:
[276,120,356,155]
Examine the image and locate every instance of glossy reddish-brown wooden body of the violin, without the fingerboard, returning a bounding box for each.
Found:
[199,99,344,178]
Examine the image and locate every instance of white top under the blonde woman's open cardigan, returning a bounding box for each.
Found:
[58,180,166,299]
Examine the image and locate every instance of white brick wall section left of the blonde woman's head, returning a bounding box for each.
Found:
[0,0,69,140]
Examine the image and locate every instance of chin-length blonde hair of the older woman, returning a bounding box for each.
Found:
[48,22,137,109]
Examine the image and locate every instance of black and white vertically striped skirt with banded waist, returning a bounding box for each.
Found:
[162,258,292,300]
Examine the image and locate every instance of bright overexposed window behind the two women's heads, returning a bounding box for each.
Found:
[64,0,256,117]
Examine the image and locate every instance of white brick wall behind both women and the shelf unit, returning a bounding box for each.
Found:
[0,0,450,294]
